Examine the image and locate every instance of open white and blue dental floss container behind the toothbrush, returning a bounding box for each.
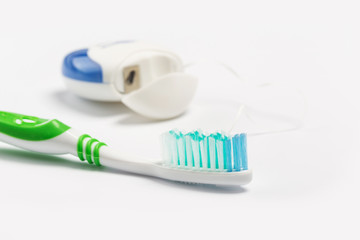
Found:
[62,41,198,119]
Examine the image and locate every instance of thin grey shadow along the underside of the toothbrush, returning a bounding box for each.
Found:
[0,148,246,194]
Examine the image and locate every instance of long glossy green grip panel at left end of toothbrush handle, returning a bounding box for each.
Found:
[0,111,70,141]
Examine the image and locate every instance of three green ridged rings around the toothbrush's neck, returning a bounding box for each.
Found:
[77,134,107,166]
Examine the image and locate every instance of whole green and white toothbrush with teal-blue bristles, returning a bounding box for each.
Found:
[0,111,252,185]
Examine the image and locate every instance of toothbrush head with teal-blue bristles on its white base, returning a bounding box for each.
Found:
[162,130,252,185]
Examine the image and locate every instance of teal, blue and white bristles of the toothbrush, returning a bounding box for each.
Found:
[162,130,248,172]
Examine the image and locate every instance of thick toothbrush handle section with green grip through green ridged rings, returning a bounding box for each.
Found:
[0,111,106,165]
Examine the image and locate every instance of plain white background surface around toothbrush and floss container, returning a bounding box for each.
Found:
[0,0,360,240]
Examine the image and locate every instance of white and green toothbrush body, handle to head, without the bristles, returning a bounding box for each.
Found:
[0,112,252,185]
